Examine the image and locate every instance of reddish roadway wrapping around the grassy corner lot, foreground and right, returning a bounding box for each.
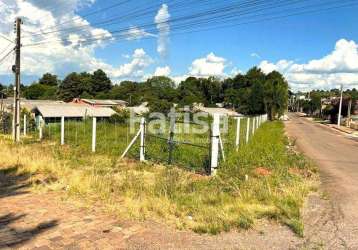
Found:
[0,114,358,249]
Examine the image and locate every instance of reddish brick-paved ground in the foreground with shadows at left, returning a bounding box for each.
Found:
[0,172,302,249]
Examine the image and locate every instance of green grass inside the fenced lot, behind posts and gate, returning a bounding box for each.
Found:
[16,118,252,173]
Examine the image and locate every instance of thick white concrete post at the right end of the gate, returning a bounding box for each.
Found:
[210,114,220,176]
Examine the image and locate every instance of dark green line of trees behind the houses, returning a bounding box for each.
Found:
[0,67,288,118]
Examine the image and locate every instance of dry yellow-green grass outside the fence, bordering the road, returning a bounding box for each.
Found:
[0,122,316,235]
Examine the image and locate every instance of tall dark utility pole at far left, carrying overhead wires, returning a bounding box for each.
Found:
[12,17,22,142]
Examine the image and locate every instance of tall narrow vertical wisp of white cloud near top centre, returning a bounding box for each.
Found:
[154,4,170,56]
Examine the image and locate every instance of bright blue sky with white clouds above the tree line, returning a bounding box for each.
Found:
[0,0,358,90]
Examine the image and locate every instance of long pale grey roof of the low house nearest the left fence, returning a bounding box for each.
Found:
[33,103,116,118]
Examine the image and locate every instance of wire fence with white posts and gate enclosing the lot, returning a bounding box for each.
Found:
[0,110,265,173]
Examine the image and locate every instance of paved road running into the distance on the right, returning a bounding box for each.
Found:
[286,114,358,249]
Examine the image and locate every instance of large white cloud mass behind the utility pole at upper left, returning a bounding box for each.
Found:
[0,0,111,76]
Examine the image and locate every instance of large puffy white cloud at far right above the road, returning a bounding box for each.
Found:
[259,39,358,90]
